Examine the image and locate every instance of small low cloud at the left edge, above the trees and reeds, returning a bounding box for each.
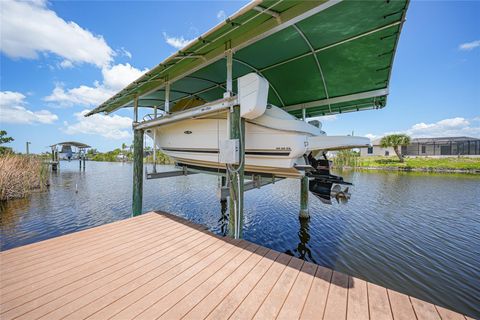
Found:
[0,91,58,124]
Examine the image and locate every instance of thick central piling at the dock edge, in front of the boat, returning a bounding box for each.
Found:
[228,105,245,239]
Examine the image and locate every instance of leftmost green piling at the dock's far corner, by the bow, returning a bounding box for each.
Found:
[132,130,143,216]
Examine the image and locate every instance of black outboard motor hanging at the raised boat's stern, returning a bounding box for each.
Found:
[306,154,352,204]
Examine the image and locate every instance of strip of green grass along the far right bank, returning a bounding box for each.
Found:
[357,157,480,170]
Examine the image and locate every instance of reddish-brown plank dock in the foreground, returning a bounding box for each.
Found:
[0,213,469,320]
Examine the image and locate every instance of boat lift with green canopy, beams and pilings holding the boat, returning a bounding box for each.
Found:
[86,0,409,238]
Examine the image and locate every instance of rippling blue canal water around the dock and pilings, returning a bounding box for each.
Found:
[1,162,480,318]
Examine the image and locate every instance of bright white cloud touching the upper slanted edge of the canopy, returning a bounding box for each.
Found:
[44,63,147,107]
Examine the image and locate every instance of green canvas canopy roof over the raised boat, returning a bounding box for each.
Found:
[87,0,408,117]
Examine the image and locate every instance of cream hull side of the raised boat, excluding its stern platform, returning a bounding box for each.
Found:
[149,119,306,176]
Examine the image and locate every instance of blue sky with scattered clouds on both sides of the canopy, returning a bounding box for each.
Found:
[0,0,480,153]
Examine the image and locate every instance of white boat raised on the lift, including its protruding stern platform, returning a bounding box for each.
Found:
[147,107,369,177]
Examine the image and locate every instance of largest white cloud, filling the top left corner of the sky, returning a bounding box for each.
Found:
[0,0,115,67]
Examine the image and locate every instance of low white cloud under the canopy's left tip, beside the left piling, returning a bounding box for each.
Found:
[62,110,132,140]
